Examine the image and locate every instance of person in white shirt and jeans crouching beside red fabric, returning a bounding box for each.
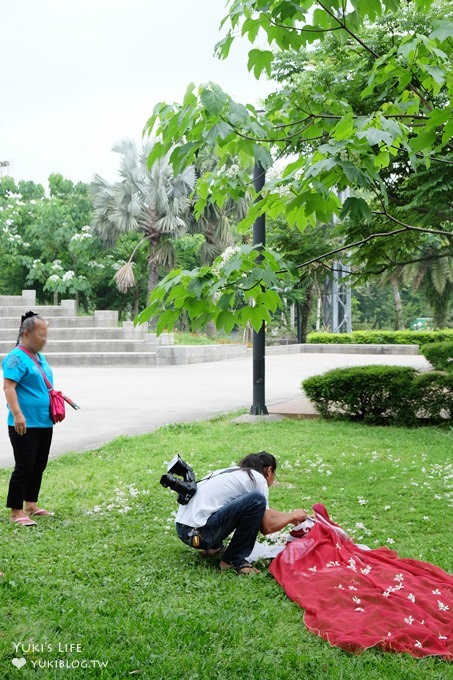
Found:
[176,451,307,574]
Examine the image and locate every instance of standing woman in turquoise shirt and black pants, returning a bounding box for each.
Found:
[2,312,53,526]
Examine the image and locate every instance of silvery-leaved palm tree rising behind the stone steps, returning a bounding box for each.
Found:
[90,139,195,294]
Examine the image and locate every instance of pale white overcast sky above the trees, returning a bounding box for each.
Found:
[0,0,269,185]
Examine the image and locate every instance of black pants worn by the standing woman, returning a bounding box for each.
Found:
[6,426,53,510]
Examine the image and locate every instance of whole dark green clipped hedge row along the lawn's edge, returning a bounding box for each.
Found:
[302,365,453,425]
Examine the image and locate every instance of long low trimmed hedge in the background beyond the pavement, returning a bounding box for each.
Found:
[307,329,453,345]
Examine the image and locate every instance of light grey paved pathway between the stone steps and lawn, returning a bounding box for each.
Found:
[0,354,429,467]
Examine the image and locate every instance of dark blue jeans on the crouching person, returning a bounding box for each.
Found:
[176,492,266,567]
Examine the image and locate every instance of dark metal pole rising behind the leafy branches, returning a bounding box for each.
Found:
[250,163,268,416]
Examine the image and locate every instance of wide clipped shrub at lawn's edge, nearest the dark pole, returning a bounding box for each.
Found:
[302,365,416,423]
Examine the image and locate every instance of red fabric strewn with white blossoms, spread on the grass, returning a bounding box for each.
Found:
[270,505,453,660]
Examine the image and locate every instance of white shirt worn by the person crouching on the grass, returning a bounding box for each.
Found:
[176,470,269,528]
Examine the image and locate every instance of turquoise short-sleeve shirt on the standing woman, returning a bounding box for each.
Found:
[2,347,53,427]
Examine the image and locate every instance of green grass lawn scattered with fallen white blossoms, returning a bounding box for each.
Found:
[0,418,453,680]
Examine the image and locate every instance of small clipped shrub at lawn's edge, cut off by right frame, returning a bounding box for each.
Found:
[412,371,453,423]
